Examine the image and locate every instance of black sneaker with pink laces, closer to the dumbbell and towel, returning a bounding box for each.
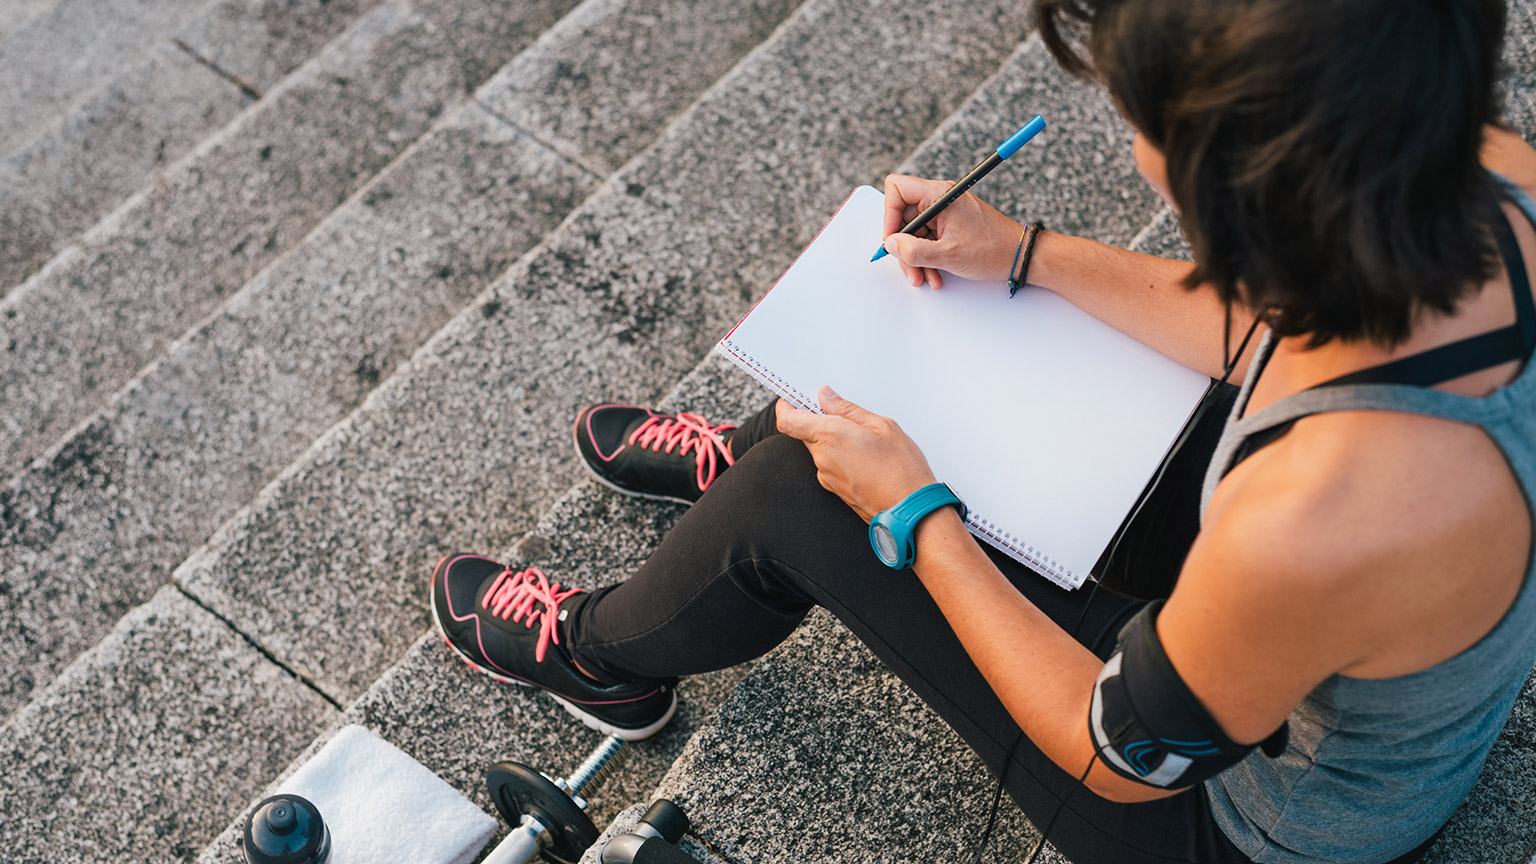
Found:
[432,553,677,741]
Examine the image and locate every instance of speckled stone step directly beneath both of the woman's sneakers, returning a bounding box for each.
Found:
[188,333,866,864]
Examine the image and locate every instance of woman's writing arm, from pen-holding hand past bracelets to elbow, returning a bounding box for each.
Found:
[885,174,1256,383]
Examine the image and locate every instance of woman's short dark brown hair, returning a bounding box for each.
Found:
[1035,0,1505,347]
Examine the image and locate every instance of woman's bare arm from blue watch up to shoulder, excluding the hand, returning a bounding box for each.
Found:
[912,488,1344,803]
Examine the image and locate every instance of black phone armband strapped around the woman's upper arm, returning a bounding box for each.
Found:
[1087,603,1287,789]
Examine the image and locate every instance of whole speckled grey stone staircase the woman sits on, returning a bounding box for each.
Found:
[0,0,1536,864]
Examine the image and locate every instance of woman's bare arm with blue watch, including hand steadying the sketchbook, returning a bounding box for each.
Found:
[779,389,1333,801]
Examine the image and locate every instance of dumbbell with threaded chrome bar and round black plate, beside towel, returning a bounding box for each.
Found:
[482,735,628,864]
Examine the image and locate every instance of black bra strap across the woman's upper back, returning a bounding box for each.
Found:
[1226,198,1536,472]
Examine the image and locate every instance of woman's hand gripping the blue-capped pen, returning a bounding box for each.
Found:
[883,174,1023,289]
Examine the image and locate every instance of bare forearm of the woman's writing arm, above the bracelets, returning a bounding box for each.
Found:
[1029,232,1255,383]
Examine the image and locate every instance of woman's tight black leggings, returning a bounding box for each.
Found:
[562,394,1437,864]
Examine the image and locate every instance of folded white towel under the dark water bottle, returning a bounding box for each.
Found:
[278,726,496,864]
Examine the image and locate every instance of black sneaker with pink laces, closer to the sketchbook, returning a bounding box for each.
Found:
[576,404,736,504]
